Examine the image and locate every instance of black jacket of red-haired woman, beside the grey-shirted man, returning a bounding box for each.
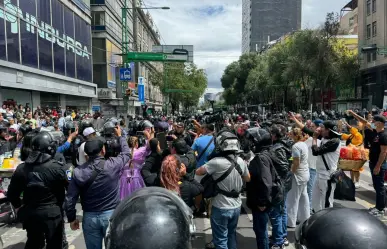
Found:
[180,176,204,207]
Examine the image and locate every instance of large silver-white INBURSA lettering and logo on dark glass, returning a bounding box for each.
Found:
[0,0,90,59]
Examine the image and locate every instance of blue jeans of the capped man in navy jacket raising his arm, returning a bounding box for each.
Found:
[82,210,114,249]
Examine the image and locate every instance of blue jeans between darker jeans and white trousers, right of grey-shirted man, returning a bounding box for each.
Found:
[270,203,287,245]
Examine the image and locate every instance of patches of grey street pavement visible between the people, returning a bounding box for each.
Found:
[0,163,387,249]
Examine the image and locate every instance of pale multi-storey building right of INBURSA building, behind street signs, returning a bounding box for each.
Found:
[90,0,163,117]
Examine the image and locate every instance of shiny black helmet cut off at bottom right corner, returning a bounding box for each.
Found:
[295,208,387,249]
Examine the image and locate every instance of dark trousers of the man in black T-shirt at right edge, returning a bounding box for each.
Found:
[369,162,387,211]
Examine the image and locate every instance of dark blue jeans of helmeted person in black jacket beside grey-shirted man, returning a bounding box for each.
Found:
[253,211,269,249]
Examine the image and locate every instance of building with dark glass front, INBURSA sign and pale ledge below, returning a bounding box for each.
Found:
[0,0,97,112]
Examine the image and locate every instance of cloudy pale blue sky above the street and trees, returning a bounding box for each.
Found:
[143,0,349,92]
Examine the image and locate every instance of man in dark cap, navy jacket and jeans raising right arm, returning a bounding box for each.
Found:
[66,125,130,249]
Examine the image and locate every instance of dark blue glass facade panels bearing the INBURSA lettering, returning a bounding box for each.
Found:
[0,0,93,82]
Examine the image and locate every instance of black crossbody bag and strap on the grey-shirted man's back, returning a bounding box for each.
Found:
[200,157,243,198]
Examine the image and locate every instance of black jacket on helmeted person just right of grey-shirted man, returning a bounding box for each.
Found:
[246,149,273,211]
